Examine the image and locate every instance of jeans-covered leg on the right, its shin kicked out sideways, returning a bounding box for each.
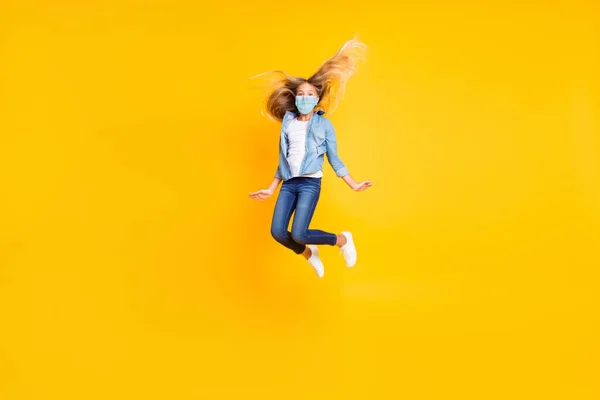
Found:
[291,178,338,246]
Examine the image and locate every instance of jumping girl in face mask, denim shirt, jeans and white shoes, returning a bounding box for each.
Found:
[250,35,372,278]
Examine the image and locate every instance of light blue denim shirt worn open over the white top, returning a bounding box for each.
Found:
[275,110,349,181]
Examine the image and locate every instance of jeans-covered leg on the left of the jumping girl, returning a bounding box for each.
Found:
[271,182,310,254]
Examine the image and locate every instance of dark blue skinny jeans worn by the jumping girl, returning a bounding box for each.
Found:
[271,177,337,254]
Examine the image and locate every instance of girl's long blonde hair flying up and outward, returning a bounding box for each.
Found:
[249,34,368,121]
